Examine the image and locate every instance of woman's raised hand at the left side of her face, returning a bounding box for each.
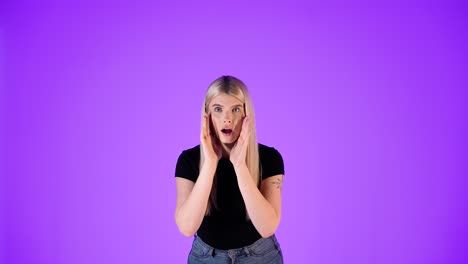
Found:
[200,114,222,164]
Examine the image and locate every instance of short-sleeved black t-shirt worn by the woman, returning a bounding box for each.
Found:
[175,144,284,249]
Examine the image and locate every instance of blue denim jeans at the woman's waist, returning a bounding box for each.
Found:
[188,235,283,264]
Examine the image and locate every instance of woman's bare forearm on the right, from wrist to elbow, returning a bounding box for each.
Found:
[234,165,280,237]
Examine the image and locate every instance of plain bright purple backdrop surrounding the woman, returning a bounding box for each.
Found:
[0,1,468,264]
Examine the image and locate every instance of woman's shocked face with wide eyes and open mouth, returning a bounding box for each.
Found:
[208,94,245,144]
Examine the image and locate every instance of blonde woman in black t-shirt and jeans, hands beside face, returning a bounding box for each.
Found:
[175,76,284,264]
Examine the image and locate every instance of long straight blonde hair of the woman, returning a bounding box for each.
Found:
[199,76,261,217]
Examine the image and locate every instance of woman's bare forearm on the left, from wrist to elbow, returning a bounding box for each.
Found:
[175,163,216,236]
